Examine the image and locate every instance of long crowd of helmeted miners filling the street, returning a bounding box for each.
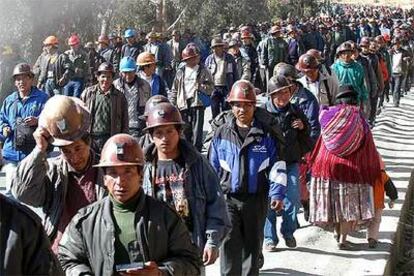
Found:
[0,2,414,275]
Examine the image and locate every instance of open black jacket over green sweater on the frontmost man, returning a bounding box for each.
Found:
[58,189,201,275]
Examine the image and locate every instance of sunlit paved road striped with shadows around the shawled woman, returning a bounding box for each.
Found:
[206,91,414,276]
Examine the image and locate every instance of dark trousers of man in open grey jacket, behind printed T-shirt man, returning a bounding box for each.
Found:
[181,106,205,152]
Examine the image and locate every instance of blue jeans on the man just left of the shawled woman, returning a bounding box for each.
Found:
[264,163,300,245]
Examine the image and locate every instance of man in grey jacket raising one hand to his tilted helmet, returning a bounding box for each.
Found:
[11,95,106,254]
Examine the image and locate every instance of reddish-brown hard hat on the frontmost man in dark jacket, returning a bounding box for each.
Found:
[94,133,144,167]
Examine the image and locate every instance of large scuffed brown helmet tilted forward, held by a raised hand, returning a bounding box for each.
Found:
[39,95,91,147]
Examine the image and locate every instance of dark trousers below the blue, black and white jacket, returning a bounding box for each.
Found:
[220,194,268,275]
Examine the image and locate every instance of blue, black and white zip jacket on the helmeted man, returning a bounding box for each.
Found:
[209,118,287,200]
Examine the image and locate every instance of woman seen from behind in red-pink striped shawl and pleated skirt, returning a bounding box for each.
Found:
[310,85,380,249]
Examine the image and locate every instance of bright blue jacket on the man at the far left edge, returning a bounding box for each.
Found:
[0,86,48,162]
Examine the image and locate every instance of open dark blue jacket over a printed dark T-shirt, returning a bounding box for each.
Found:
[143,140,231,254]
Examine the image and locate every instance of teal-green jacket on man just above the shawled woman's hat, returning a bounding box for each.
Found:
[332,59,368,102]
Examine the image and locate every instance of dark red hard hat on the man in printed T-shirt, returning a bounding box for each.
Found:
[144,102,184,130]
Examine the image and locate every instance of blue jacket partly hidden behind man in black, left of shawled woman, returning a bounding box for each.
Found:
[291,82,321,144]
